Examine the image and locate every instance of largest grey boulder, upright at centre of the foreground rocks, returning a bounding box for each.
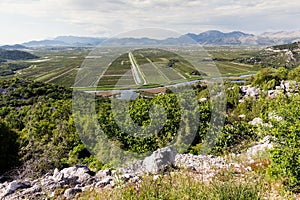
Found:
[142,146,177,173]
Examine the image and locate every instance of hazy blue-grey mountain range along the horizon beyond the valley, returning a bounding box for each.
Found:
[0,30,300,49]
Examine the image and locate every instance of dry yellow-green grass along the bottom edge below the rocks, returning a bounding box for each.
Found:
[78,172,265,200]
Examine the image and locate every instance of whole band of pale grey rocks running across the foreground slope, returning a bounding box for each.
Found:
[0,141,272,200]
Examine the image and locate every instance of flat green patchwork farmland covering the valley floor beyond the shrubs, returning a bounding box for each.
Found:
[0,47,261,89]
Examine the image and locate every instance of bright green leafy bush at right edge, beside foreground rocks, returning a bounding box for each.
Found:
[268,96,300,192]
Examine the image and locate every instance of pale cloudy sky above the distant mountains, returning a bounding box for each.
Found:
[0,0,300,44]
